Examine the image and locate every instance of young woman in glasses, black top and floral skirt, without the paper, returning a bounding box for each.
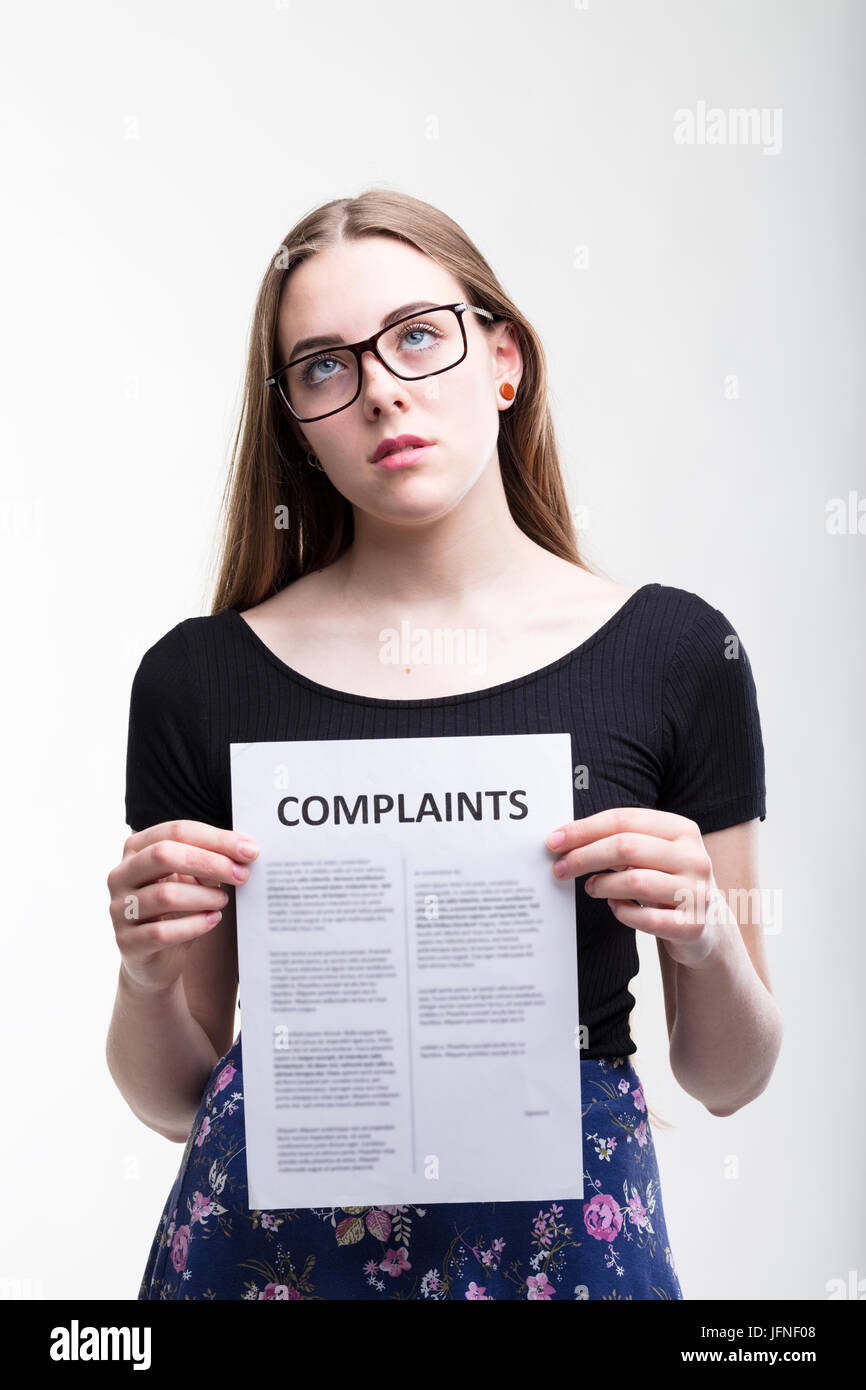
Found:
[107,190,781,1300]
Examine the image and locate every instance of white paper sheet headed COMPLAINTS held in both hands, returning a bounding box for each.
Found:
[231,733,584,1211]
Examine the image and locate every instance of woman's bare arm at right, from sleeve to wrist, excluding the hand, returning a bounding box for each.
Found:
[656,820,783,1116]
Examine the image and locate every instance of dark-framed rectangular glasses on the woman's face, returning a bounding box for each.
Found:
[264,303,493,424]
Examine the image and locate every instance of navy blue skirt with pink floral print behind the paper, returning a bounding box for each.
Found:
[138,1034,683,1300]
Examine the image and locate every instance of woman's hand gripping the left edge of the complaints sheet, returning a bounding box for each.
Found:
[107,820,259,992]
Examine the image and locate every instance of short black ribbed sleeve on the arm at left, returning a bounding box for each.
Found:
[126,623,231,831]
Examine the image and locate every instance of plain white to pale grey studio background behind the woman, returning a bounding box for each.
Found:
[0,0,866,1300]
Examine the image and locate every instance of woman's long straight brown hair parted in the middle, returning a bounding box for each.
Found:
[211,189,596,614]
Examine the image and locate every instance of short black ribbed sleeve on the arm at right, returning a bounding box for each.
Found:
[657,599,767,834]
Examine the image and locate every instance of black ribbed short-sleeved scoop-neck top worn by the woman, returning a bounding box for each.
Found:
[126,584,766,1058]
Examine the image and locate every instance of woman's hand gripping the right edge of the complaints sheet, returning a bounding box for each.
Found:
[546,806,728,966]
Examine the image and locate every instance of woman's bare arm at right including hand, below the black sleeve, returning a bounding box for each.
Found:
[546,806,783,1115]
